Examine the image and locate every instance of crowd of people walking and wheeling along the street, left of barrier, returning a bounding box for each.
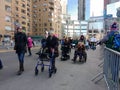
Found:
[0,27,97,75]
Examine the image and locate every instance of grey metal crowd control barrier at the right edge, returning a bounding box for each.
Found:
[103,47,120,90]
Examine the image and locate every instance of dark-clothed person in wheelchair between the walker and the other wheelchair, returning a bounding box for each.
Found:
[61,38,70,60]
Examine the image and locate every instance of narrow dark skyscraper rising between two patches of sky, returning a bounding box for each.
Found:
[78,0,86,20]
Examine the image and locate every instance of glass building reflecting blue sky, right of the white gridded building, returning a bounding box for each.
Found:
[87,16,104,40]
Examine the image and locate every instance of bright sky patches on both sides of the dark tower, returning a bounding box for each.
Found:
[68,0,104,20]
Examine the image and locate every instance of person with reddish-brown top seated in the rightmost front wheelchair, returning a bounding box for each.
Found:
[72,42,86,62]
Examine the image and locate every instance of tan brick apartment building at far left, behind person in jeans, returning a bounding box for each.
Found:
[0,0,32,40]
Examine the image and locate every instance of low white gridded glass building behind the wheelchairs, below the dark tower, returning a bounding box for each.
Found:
[64,19,88,39]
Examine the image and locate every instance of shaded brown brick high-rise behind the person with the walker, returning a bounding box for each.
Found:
[33,0,61,37]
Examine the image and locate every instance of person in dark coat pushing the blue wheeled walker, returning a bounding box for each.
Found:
[46,30,59,71]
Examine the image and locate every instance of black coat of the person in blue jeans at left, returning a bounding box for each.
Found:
[14,32,27,53]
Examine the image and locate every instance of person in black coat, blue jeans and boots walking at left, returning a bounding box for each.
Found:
[14,27,27,75]
